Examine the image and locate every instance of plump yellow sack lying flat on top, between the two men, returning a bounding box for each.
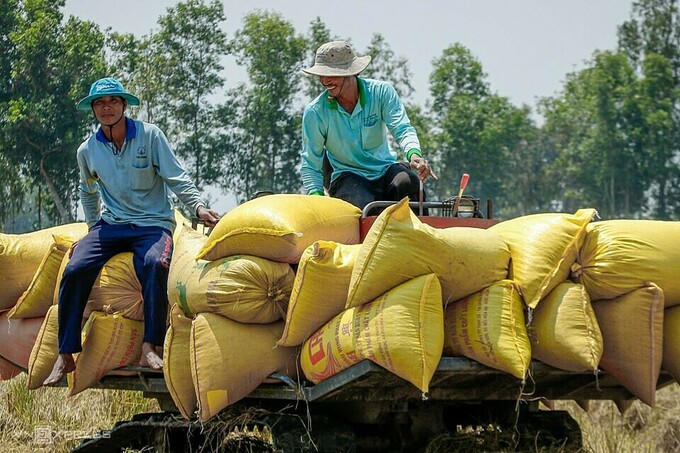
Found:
[196,194,361,263]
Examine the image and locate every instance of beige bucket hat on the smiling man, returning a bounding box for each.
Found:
[302,41,371,77]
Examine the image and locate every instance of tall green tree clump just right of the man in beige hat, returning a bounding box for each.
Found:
[430,44,544,216]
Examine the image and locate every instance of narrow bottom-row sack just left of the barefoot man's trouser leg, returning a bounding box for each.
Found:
[26,305,59,390]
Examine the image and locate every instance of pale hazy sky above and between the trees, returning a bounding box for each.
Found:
[64,0,633,213]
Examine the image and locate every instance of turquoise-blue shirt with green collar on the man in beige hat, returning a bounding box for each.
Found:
[300,77,420,194]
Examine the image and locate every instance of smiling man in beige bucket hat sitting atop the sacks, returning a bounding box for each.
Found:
[301,41,437,209]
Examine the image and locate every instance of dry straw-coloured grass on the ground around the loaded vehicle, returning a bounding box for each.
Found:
[0,374,680,453]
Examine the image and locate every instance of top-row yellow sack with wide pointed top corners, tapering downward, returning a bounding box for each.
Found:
[489,209,597,308]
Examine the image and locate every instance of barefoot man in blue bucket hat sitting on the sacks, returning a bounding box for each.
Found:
[43,77,219,385]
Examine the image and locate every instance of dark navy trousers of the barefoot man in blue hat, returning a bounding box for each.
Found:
[59,220,173,354]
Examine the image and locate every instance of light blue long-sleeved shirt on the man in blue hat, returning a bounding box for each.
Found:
[77,117,203,231]
